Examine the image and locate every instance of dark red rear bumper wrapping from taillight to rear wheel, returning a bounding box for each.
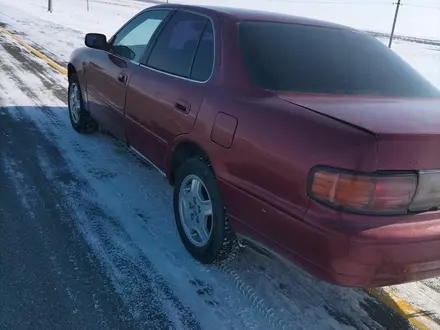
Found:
[224,178,440,287]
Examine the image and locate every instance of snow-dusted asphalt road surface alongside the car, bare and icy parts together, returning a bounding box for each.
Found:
[0,29,416,330]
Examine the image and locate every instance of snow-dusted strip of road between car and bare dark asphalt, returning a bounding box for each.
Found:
[0,15,438,329]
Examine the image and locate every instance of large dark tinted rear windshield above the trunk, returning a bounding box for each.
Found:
[239,21,440,97]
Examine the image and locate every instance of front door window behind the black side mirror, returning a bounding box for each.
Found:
[110,10,169,62]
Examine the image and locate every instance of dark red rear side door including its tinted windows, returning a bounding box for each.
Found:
[126,10,214,169]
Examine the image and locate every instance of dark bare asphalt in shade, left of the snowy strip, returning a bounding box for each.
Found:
[0,107,139,329]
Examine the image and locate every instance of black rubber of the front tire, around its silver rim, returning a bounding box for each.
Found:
[67,74,98,133]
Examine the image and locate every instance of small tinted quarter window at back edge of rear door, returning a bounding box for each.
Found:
[190,21,214,81]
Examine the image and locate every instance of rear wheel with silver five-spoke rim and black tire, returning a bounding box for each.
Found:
[173,158,236,264]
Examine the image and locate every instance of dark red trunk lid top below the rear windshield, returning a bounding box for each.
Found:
[277,93,440,135]
